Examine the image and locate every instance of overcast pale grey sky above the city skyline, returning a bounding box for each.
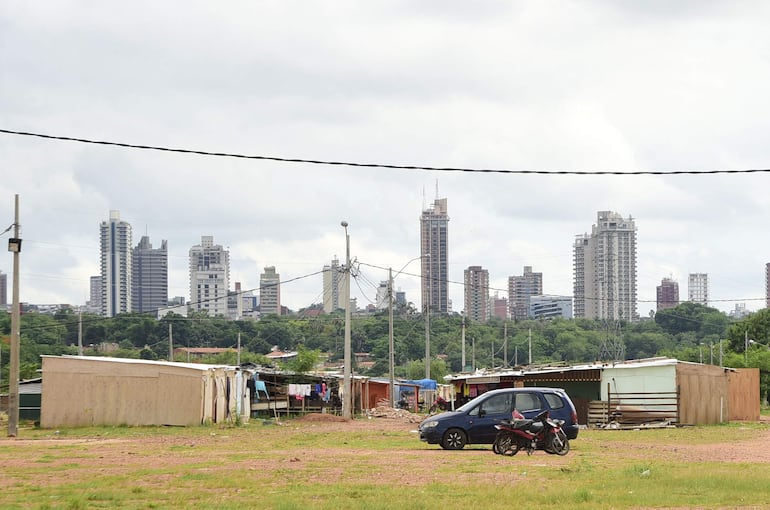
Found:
[0,0,770,316]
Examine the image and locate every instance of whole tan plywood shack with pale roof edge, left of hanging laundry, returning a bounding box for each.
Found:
[40,356,251,428]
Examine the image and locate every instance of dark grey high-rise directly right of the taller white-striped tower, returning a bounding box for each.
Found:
[131,236,168,313]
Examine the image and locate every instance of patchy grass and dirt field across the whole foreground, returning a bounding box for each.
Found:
[0,415,770,510]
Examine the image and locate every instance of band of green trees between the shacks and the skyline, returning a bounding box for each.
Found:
[0,302,770,394]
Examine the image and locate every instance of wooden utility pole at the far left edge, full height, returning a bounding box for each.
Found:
[8,195,21,437]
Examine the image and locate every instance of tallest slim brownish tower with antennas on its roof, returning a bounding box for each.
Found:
[420,198,451,314]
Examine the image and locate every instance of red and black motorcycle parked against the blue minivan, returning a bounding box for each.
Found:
[492,409,569,456]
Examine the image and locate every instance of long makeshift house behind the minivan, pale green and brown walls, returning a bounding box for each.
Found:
[446,358,760,425]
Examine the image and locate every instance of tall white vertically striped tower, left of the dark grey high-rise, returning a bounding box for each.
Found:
[99,211,132,317]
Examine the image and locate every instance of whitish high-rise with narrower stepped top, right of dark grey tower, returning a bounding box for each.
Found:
[188,236,230,317]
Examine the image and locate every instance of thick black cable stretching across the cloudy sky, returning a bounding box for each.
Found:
[0,129,770,175]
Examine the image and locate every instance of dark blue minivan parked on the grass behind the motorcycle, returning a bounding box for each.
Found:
[419,387,579,450]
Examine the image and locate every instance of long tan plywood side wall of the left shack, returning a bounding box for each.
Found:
[40,357,206,428]
